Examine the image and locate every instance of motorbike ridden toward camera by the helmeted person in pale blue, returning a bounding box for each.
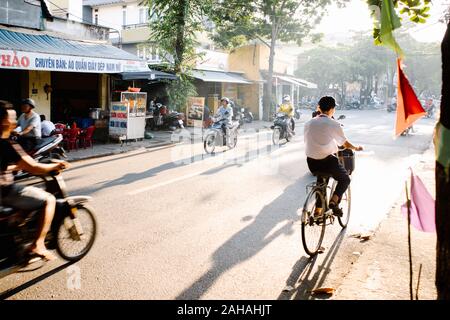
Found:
[203,115,239,154]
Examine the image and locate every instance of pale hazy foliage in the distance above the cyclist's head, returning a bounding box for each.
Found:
[296,34,441,103]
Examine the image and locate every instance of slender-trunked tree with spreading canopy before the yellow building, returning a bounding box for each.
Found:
[211,0,348,120]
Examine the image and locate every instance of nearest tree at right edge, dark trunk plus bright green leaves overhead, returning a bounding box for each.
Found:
[368,0,450,300]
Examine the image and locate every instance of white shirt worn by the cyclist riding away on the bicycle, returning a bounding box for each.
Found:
[304,115,347,160]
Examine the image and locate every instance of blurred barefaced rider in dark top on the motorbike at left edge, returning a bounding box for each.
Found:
[0,101,68,260]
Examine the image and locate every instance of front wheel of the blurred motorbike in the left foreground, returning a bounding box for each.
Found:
[55,204,97,261]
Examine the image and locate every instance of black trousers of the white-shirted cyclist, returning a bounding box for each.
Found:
[306,155,350,201]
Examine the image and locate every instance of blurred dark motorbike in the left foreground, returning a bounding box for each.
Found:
[0,172,97,278]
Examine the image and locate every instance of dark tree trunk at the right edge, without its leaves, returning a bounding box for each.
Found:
[436,24,450,300]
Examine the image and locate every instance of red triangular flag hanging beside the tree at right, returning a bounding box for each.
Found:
[395,59,426,136]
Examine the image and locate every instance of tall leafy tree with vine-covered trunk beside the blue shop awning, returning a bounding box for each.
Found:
[148,0,211,111]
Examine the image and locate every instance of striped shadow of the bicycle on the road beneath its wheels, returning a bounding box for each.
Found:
[278,228,346,300]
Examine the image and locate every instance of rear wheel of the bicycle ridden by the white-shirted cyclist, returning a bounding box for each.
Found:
[301,188,326,257]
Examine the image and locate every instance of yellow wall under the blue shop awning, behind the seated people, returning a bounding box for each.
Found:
[26,70,52,119]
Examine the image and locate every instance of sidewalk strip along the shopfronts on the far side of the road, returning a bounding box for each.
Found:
[66,121,272,162]
